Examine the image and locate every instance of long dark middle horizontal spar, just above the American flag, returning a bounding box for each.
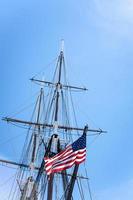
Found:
[2,117,106,134]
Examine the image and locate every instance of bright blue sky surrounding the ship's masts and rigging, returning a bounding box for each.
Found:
[0,0,133,200]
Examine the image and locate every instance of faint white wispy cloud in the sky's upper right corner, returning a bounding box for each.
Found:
[84,0,133,36]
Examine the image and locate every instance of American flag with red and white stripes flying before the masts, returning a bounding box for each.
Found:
[44,132,86,175]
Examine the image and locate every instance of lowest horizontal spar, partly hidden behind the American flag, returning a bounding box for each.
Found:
[0,159,89,179]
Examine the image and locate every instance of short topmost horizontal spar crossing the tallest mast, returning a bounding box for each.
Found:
[30,78,88,91]
